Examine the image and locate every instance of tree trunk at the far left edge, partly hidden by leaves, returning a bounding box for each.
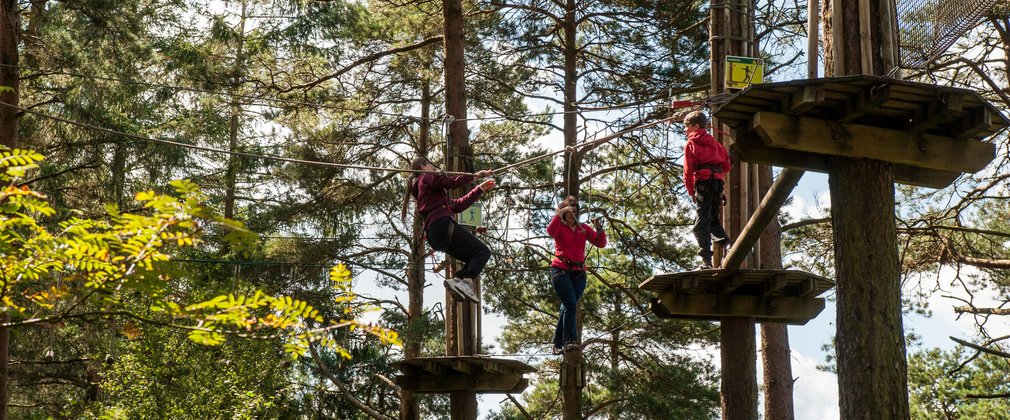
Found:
[0,0,20,420]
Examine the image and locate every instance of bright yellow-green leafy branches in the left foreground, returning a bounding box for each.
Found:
[0,149,399,356]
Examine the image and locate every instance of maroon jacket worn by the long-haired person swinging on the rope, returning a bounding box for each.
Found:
[410,174,484,230]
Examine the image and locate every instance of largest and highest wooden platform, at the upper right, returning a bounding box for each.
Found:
[712,76,1010,188]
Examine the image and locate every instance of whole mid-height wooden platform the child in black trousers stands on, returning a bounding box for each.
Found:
[638,270,834,325]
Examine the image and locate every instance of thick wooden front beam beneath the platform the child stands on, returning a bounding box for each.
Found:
[657,293,824,324]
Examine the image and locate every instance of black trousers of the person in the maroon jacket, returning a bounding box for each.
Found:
[425,217,491,279]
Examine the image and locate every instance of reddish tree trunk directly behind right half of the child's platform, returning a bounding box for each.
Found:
[758,166,795,420]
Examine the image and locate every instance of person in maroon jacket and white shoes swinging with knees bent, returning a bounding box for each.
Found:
[402,158,495,303]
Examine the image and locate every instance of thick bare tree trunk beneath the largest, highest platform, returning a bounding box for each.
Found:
[829,159,909,419]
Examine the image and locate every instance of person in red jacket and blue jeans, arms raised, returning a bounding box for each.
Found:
[547,196,607,354]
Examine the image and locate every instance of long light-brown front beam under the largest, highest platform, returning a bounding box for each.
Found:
[751,112,996,173]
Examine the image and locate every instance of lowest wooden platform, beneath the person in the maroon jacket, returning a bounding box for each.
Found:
[393,355,536,394]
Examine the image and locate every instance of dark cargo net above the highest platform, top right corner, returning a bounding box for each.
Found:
[895,0,1007,69]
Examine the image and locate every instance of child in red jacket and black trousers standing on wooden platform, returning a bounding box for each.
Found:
[684,111,732,270]
